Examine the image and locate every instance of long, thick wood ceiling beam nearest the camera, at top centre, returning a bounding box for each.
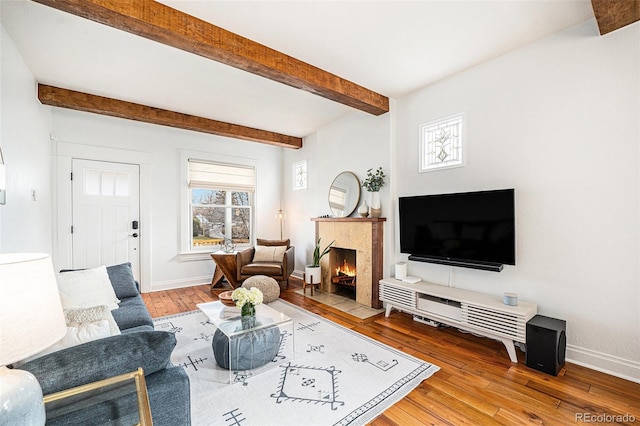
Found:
[34,0,389,115]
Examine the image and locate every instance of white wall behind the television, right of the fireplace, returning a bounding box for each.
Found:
[394,21,640,380]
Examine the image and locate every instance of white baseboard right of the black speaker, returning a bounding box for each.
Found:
[566,345,640,383]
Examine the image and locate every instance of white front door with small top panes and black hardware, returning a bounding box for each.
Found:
[72,159,140,280]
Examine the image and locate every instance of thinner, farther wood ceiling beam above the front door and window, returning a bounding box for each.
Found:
[38,84,302,149]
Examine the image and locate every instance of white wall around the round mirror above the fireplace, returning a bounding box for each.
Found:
[283,112,394,273]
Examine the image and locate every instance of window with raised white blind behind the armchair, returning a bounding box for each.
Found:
[188,159,255,250]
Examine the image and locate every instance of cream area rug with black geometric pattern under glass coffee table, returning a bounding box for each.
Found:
[155,300,439,426]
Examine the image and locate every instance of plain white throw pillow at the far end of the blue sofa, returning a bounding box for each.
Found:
[56,266,120,310]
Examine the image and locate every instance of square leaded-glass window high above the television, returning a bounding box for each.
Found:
[419,114,465,172]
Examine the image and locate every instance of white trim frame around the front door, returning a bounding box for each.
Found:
[52,141,152,292]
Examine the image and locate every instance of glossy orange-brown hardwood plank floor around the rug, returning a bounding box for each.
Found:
[143,280,640,426]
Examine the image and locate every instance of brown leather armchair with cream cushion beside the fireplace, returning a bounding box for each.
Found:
[236,238,295,288]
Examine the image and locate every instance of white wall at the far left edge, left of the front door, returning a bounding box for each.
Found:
[0,27,52,253]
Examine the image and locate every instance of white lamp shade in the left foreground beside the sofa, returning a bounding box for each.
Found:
[0,253,67,366]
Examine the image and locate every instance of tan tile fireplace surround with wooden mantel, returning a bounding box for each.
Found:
[311,217,387,308]
